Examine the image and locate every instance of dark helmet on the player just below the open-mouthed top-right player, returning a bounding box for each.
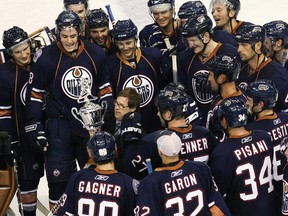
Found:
[236,24,266,44]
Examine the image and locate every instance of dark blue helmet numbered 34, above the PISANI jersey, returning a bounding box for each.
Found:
[217,97,248,128]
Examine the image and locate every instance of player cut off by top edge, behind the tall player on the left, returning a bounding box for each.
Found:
[63,0,89,37]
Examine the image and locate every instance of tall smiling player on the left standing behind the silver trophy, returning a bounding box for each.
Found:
[26,11,113,210]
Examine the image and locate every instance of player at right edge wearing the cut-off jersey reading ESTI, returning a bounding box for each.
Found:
[246,80,288,215]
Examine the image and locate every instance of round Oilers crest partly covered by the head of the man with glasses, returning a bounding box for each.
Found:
[123,75,154,107]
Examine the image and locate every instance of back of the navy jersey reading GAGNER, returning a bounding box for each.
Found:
[59,168,138,216]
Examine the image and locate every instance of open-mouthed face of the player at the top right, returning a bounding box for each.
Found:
[211,2,229,28]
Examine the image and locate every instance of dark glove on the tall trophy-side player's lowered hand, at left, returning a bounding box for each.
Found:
[25,122,48,152]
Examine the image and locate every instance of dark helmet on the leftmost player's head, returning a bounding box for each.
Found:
[2,26,29,53]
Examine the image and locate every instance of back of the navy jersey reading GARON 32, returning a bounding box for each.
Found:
[136,161,225,215]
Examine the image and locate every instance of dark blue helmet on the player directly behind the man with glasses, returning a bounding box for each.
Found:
[112,19,138,41]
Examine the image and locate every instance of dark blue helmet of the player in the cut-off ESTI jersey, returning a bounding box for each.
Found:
[246,79,278,109]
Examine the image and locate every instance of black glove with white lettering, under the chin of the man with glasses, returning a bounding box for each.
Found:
[121,112,142,144]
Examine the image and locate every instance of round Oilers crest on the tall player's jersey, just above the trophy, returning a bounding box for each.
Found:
[61,66,93,100]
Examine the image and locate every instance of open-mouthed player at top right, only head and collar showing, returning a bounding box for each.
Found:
[210,0,251,36]
